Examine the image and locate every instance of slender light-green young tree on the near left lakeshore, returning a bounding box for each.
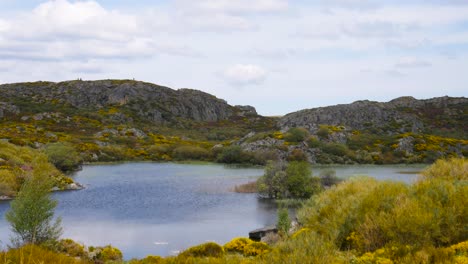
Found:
[6,168,62,246]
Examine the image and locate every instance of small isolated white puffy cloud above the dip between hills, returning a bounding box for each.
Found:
[222,64,267,85]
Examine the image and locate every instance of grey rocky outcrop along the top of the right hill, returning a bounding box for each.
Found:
[279,97,468,133]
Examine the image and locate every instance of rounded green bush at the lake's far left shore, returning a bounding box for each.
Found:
[44,143,82,171]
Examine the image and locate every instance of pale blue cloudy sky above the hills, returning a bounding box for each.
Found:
[0,0,468,115]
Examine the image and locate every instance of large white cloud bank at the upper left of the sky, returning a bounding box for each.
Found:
[0,0,199,61]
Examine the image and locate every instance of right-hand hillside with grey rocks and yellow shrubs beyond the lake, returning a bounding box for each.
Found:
[236,97,468,164]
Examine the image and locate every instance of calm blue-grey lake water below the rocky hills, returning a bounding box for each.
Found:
[0,163,424,259]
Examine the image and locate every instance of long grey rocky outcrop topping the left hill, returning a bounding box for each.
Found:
[0,80,255,123]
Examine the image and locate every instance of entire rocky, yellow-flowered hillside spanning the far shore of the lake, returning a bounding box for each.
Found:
[0,80,468,164]
